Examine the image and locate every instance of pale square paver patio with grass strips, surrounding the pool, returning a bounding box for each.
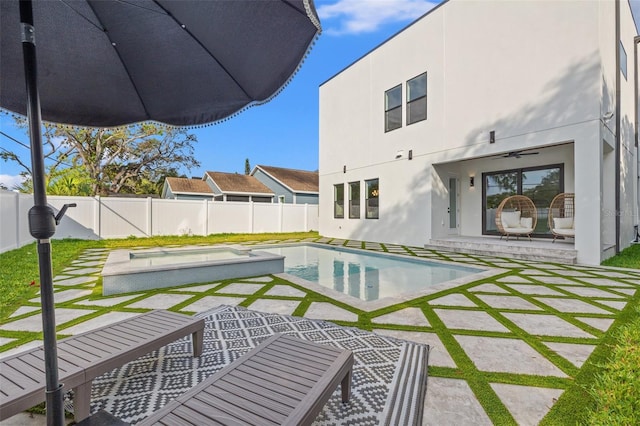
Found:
[0,238,640,425]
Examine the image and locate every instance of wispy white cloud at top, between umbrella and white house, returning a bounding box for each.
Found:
[317,0,437,35]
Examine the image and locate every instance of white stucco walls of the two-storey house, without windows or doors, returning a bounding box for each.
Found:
[319,0,637,263]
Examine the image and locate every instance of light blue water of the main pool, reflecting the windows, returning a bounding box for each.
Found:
[257,245,483,301]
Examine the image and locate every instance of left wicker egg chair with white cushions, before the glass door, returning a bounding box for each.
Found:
[496,195,538,241]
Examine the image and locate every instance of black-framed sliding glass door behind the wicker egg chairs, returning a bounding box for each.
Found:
[482,164,564,237]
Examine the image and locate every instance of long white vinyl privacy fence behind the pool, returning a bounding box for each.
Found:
[0,190,318,253]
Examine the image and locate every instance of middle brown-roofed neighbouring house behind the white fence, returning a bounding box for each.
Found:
[203,172,274,203]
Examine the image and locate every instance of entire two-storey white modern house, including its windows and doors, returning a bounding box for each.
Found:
[319,0,639,264]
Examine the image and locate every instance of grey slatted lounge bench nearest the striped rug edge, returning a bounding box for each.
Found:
[137,334,354,426]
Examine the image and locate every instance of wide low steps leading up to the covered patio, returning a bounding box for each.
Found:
[424,237,578,265]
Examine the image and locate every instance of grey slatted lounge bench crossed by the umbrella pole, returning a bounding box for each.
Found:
[0,310,204,421]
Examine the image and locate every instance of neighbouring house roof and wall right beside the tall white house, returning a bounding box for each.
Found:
[251,165,318,204]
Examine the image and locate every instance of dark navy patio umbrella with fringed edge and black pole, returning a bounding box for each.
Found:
[0,0,320,425]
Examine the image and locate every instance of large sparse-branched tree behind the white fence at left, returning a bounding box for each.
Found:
[0,121,200,195]
